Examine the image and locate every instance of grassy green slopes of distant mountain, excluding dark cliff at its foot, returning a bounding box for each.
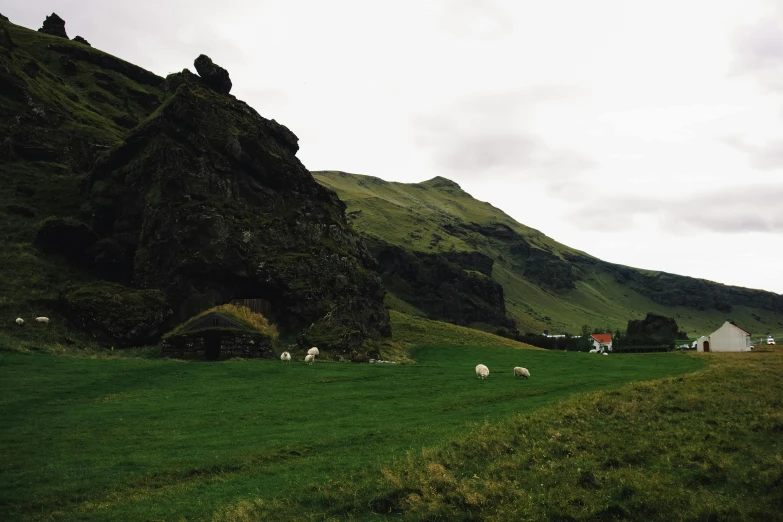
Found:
[313,171,783,336]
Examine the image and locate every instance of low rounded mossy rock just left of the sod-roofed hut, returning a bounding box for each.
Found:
[60,281,172,347]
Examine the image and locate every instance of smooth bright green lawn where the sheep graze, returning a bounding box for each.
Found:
[0,346,703,520]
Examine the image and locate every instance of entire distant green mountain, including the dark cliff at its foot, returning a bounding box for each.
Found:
[313,171,783,335]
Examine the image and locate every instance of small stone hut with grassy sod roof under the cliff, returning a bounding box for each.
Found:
[163,304,277,361]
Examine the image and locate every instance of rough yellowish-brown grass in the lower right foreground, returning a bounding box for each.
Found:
[362,354,783,520]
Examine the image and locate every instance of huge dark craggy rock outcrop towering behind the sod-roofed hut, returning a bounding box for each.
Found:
[85,73,390,354]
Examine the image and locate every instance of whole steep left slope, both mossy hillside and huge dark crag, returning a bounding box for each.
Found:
[0,14,390,354]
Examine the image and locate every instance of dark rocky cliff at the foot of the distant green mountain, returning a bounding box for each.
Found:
[371,239,514,328]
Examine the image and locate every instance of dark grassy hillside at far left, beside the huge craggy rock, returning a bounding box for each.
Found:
[0,14,163,340]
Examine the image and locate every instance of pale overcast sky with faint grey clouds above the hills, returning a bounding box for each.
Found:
[6,0,783,294]
